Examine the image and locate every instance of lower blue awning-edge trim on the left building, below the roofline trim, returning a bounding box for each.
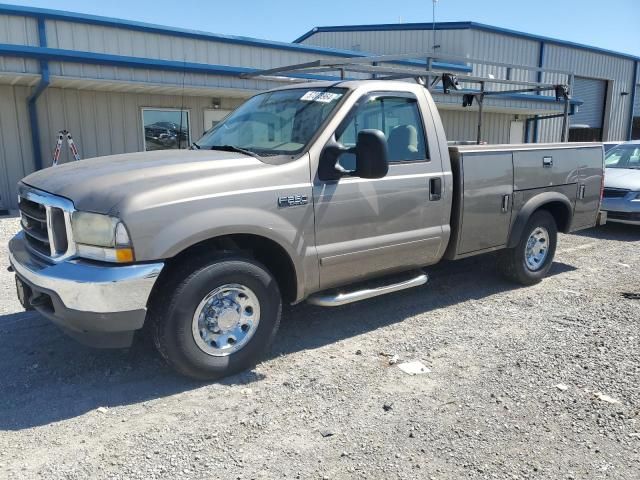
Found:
[0,43,350,81]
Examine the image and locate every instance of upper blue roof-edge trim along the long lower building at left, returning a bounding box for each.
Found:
[0,4,471,72]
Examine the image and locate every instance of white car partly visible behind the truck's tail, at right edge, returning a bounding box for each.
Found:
[601,140,640,225]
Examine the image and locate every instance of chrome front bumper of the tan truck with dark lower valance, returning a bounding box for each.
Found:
[9,232,164,347]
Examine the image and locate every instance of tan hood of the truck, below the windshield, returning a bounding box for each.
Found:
[22,150,269,213]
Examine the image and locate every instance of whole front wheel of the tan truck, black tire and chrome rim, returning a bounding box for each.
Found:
[150,255,282,380]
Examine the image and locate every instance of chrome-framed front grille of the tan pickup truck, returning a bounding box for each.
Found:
[18,185,74,261]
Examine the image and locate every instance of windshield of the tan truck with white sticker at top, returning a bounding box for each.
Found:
[195,87,346,157]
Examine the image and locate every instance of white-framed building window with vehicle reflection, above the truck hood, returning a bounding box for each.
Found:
[142,108,191,151]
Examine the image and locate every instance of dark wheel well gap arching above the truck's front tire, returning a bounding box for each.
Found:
[161,234,298,302]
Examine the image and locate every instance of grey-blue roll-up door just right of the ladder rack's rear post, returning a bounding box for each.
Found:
[569,77,607,142]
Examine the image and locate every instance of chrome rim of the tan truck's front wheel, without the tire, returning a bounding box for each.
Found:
[191,284,260,357]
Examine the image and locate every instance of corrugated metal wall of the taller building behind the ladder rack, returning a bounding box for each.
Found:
[303,29,634,142]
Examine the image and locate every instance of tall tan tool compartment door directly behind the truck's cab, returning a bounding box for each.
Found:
[458,152,513,255]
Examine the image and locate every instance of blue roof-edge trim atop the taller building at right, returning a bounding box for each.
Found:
[293,22,640,60]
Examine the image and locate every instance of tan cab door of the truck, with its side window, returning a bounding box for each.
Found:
[313,92,448,289]
